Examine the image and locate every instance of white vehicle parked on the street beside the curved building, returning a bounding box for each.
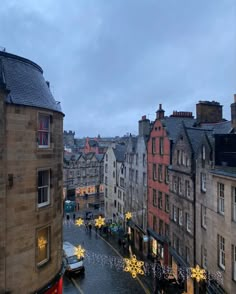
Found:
[63,241,85,275]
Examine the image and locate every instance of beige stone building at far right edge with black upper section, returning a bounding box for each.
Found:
[196,95,236,293]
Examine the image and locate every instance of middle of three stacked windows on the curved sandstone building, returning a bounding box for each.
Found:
[38,170,50,207]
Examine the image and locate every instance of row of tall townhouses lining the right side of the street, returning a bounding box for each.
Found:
[104,99,236,293]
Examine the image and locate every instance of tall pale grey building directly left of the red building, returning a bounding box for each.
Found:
[124,116,151,255]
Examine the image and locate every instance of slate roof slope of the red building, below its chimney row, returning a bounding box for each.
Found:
[162,117,196,142]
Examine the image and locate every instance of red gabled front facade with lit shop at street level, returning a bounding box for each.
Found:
[147,105,170,265]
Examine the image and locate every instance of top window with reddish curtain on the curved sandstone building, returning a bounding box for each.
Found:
[38,113,50,148]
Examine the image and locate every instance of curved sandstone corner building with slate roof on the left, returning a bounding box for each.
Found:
[0,52,64,294]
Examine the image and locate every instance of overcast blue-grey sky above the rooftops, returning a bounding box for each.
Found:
[0,0,236,137]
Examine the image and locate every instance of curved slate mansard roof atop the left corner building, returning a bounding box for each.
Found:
[0,51,62,112]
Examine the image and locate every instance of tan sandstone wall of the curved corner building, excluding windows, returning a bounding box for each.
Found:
[0,103,63,293]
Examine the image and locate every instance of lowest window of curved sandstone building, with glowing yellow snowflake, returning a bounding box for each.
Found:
[36,227,49,266]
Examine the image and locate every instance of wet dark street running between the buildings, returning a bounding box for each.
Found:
[63,222,150,294]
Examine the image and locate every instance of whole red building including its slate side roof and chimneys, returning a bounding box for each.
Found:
[147,104,195,265]
